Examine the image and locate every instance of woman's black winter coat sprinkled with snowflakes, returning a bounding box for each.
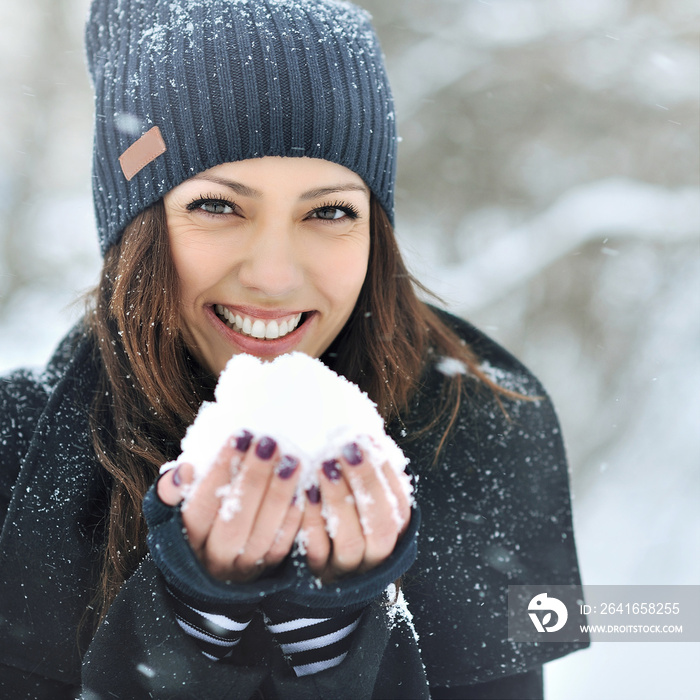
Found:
[0,315,586,700]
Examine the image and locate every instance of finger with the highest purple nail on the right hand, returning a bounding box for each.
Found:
[342,443,400,571]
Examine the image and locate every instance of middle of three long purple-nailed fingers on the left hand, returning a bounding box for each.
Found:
[203,437,276,578]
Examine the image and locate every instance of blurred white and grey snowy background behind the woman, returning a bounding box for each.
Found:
[0,0,700,700]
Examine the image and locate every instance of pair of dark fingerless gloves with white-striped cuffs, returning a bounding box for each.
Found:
[143,484,420,676]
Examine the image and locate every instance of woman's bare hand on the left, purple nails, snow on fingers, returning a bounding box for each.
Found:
[157,432,302,583]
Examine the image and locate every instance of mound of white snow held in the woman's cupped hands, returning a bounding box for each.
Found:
[161,352,412,514]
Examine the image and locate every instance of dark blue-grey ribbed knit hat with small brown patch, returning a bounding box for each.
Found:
[85,0,396,253]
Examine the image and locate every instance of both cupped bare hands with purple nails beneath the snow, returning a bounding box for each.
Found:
[157,431,411,583]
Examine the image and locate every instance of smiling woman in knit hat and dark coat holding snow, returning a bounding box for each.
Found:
[0,0,579,698]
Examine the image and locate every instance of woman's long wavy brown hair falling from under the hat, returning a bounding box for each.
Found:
[87,194,512,624]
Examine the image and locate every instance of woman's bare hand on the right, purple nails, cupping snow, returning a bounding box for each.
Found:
[301,443,411,582]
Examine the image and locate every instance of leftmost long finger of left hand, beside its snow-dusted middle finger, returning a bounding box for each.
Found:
[182,431,253,559]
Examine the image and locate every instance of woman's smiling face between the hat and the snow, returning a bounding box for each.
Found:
[164,157,370,374]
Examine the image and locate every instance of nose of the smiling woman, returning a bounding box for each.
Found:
[238,221,304,297]
